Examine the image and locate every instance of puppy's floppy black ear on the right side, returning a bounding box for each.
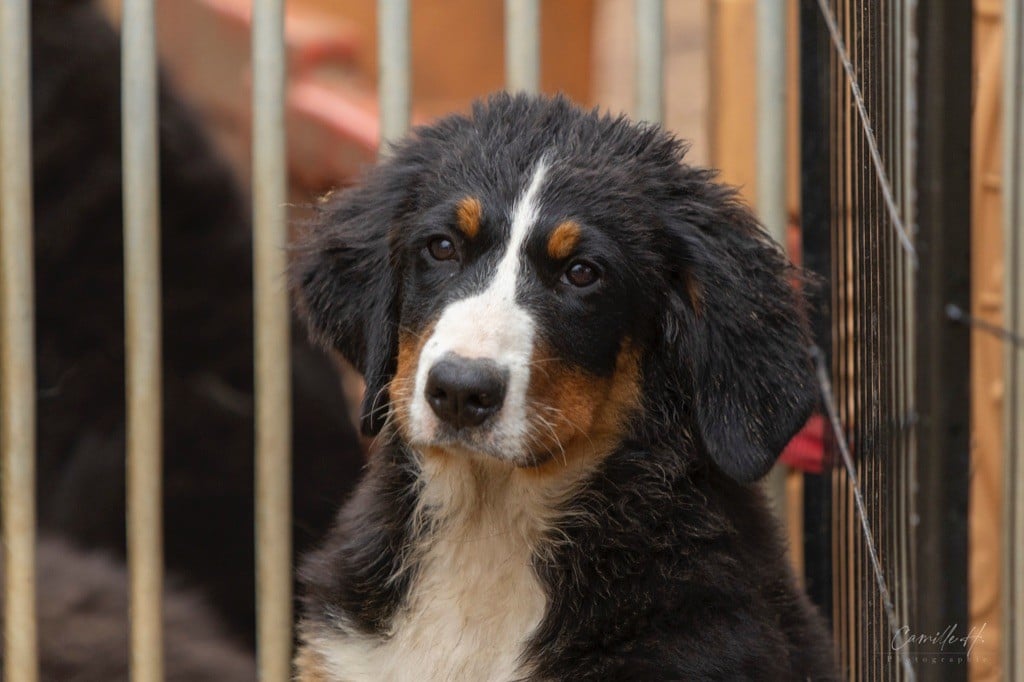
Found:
[668,185,817,482]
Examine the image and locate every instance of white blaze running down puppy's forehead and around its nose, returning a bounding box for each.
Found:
[410,158,548,448]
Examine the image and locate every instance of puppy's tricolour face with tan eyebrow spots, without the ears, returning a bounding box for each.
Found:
[389,155,651,466]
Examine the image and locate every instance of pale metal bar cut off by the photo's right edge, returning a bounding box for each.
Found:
[1002,0,1024,680]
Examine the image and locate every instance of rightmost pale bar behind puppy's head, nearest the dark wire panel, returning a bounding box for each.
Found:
[757,0,788,522]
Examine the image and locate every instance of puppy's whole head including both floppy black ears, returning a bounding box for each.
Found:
[296,95,815,481]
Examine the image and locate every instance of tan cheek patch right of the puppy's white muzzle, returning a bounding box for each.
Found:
[528,341,640,474]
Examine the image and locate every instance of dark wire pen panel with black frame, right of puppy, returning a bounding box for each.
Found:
[801,0,972,680]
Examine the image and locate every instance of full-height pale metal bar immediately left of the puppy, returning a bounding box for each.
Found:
[252,0,292,682]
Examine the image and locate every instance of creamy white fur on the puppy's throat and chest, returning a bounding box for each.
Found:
[309,456,580,682]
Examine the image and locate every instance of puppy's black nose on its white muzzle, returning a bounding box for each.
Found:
[425,353,508,429]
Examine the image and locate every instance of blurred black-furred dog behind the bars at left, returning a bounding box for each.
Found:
[32,0,362,642]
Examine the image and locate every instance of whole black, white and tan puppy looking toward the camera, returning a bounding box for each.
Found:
[294,94,834,682]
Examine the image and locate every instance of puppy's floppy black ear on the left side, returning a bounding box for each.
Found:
[292,164,413,435]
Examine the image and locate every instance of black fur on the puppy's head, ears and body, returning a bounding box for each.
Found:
[295,95,834,680]
